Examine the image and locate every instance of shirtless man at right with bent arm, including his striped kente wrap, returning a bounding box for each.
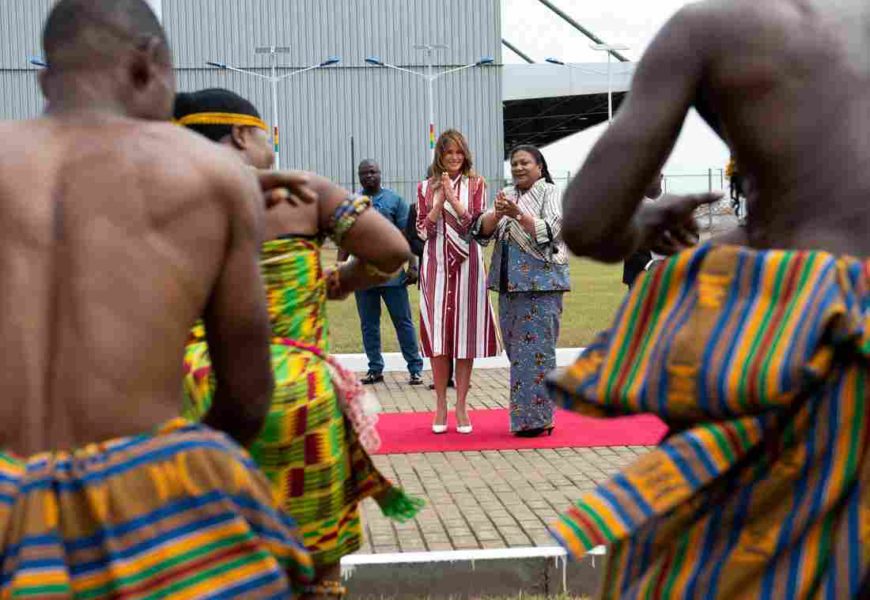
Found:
[551,0,870,599]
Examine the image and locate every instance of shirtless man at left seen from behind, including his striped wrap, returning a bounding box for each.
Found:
[0,0,311,597]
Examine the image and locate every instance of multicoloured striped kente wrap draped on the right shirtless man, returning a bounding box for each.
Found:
[551,246,870,600]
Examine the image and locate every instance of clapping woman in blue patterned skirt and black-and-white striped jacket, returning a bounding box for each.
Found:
[474,145,570,437]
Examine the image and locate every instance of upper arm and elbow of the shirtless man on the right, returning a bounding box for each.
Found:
[562,6,713,262]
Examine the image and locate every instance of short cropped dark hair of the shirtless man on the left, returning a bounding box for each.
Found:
[42,0,169,68]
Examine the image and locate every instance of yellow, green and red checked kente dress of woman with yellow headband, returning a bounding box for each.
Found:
[184,238,422,567]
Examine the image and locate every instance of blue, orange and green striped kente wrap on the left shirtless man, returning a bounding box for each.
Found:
[0,419,314,599]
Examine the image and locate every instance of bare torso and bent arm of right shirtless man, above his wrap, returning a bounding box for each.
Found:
[563,0,870,261]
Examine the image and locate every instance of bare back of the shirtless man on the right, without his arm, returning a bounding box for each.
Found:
[696,0,870,256]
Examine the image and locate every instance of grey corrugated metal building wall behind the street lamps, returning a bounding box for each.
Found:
[0,0,503,199]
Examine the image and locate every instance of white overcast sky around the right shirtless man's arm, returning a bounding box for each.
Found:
[502,0,728,187]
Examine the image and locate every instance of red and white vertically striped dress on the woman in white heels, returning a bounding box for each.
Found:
[417,176,501,359]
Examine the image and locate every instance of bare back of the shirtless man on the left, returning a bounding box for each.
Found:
[0,116,270,455]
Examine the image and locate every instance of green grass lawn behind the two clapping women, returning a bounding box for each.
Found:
[328,258,626,353]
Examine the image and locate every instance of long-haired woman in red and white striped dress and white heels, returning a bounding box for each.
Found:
[417,129,501,433]
